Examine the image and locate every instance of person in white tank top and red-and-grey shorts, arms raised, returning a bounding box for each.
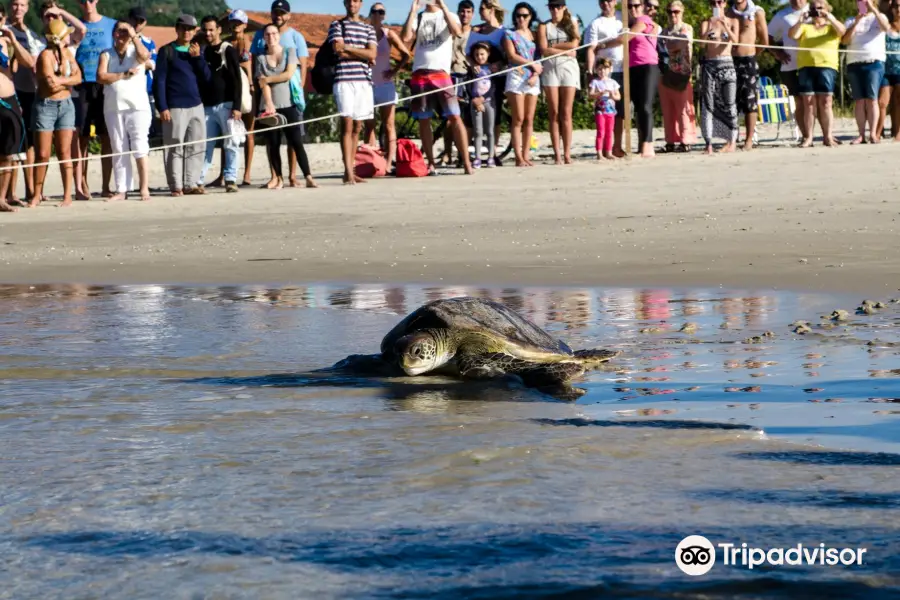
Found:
[400,0,472,175]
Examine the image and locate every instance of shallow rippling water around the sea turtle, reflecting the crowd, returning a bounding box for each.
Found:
[0,285,900,598]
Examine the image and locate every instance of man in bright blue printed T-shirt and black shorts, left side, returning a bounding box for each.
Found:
[75,0,116,198]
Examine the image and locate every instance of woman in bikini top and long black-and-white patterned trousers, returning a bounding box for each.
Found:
[700,0,738,154]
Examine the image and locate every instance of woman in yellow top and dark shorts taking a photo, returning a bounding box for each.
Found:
[788,0,847,148]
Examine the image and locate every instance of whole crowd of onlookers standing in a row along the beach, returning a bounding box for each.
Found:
[0,0,900,211]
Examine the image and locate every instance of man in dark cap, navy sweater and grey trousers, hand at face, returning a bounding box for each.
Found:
[153,15,212,197]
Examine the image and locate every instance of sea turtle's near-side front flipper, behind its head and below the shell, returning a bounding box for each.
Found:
[456,352,584,387]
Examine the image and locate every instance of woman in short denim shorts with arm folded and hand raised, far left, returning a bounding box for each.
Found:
[29,19,81,207]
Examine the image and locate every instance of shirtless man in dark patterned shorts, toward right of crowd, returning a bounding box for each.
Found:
[725,0,769,150]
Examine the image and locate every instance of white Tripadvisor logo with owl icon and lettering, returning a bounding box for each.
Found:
[675,535,867,577]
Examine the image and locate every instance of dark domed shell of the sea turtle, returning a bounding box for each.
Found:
[381,297,572,356]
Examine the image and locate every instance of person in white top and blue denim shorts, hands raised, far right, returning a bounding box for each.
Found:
[841,0,891,144]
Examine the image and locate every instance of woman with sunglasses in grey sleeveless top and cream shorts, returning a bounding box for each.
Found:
[536,0,581,165]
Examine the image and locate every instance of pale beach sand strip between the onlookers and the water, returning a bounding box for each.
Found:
[0,119,900,295]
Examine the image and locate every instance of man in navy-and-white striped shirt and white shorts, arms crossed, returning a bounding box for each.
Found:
[326,0,378,185]
